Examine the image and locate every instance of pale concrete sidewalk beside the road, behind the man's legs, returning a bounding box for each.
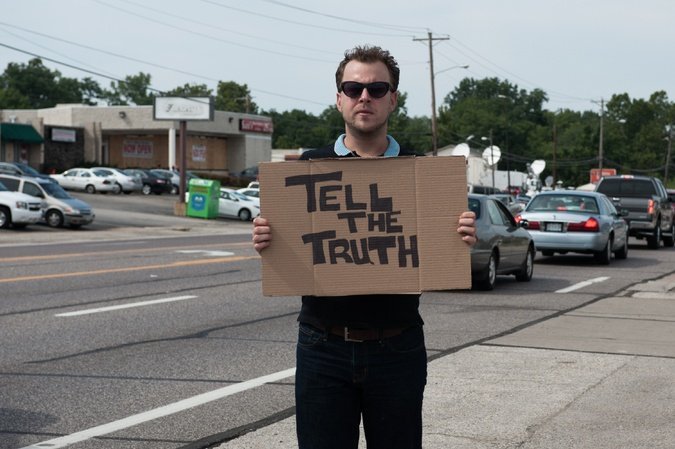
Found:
[217,274,675,449]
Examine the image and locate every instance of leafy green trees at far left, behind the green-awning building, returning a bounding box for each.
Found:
[0,58,101,109]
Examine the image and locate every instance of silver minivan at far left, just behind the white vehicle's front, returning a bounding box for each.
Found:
[0,174,94,228]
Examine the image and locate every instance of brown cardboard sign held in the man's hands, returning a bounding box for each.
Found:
[259,156,471,296]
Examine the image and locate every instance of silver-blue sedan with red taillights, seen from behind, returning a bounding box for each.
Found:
[516,190,629,265]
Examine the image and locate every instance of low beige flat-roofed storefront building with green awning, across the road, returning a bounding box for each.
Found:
[0,104,273,175]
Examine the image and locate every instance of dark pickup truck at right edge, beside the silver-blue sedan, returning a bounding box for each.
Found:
[595,175,675,249]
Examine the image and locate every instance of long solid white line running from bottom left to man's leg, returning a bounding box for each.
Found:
[21,368,295,449]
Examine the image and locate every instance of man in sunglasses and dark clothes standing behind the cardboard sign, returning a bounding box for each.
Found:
[253,46,475,449]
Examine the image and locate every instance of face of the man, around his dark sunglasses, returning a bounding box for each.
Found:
[337,61,398,134]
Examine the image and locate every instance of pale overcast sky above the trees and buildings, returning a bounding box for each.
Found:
[0,0,675,121]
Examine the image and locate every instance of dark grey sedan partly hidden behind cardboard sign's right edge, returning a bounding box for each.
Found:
[468,193,535,290]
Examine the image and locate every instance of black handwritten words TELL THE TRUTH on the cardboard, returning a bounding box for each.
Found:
[286,171,419,268]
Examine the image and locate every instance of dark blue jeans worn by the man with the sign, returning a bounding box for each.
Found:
[295,324,427,449]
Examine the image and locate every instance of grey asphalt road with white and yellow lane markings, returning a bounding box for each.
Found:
[0,191,675,449]
